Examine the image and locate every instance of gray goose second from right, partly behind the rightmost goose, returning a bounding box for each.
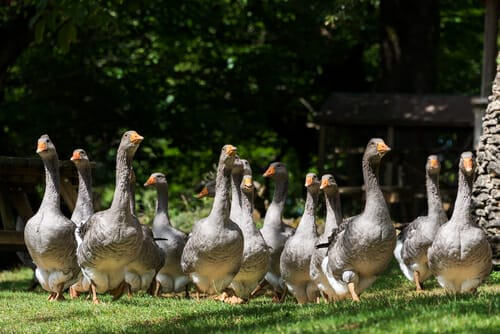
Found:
[394,155,448,291]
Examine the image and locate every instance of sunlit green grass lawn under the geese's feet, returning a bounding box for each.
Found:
[0,263,500,333]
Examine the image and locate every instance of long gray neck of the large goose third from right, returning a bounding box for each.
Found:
[363,157,389,221]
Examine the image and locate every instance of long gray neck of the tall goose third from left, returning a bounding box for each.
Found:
[111,148,132,214]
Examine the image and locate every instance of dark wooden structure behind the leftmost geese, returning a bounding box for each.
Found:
[0,156,78,251]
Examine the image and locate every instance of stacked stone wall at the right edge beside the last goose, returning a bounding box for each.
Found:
[473,55,500,265]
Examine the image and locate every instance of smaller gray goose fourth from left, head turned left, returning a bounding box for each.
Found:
[144,173,189,296]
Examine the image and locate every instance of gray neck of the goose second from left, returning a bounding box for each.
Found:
[71,165,94,225]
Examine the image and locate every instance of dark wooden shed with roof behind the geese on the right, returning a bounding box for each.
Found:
[315,93,475,222]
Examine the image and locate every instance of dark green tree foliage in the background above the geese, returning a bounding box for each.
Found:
[0,0,484,216]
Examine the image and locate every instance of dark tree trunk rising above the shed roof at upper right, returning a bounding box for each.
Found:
[380,0,439,93]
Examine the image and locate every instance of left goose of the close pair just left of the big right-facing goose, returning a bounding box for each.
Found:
[280,173,320,304]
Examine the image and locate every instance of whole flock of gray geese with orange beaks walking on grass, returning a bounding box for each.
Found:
[20,131,492,304]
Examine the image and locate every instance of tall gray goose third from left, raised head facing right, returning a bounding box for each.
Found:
[77,131,144,304]
